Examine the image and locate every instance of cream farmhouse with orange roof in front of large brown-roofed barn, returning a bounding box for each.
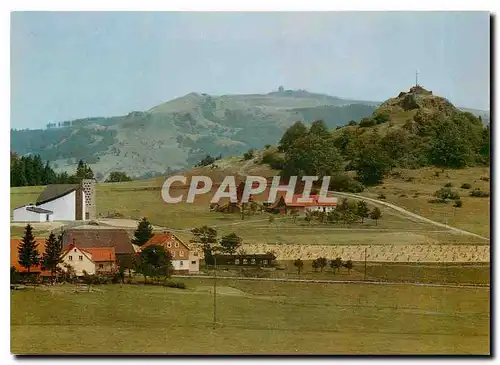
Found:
[59,243,116,276]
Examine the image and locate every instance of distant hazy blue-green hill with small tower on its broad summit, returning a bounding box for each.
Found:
[11,89,378,176]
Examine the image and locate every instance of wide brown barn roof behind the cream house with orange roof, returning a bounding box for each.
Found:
[63,228,135,254]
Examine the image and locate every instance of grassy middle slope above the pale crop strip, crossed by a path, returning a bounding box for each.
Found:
[11,166,489,245]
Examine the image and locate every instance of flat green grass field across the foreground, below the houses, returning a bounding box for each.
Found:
[11,279,490,354]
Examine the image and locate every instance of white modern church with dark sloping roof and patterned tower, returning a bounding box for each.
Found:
[13,179,96,222]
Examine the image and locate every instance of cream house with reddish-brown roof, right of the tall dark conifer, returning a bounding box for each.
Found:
[141,232,200,273]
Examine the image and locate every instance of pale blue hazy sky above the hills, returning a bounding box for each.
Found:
[11,12,490,128]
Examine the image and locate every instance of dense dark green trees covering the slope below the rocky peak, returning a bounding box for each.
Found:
[262,104,490,191]
